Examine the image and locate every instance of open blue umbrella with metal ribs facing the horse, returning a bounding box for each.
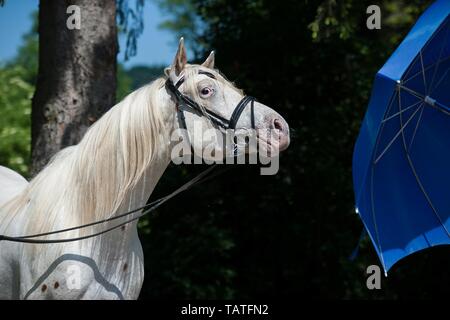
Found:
[353,0,450,273]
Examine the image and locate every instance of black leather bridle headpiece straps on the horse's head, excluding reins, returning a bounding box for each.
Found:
[166,70,256,137]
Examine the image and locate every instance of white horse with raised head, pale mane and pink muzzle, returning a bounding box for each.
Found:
[0,39,289,299]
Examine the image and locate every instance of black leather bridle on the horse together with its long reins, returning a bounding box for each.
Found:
[0,70,256,244]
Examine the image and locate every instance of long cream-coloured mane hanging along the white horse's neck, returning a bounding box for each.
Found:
[0,78,167,236]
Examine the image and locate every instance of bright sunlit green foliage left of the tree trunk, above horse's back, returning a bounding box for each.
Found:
[0,65,34,176]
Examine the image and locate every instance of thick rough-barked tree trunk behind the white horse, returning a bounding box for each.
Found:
[31,0,118,176]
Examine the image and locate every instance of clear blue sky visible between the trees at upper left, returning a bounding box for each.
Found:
[0,0,185,67]
